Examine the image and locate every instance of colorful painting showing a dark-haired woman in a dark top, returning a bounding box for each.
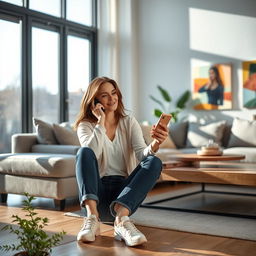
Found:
[192,62,232,110]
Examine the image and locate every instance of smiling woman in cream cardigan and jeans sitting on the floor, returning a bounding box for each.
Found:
[75,77,168,246]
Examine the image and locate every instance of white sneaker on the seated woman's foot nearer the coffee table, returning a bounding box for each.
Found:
[114,216,147,246]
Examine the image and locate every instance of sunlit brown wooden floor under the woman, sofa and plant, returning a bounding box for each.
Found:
[0,183,256,256]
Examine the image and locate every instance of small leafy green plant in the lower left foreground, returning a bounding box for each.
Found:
[0,193,66,256]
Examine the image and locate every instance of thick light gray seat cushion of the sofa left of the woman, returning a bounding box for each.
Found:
[0,153,76,177]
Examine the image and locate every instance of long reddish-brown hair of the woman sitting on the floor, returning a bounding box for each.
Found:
[74,77,126,129]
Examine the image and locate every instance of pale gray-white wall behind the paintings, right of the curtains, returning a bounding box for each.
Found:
[138,0,256,122]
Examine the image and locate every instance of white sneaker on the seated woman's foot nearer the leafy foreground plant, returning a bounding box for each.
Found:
[77,214,100,242]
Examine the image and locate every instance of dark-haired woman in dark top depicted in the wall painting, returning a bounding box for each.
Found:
[199,66,224,105]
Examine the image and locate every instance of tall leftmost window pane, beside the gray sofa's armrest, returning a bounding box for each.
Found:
[0,15,21,152]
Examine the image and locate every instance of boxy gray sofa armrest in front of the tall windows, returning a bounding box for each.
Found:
[12,133,37,153]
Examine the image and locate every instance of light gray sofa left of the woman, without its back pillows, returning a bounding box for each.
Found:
[0,134,79,210]
